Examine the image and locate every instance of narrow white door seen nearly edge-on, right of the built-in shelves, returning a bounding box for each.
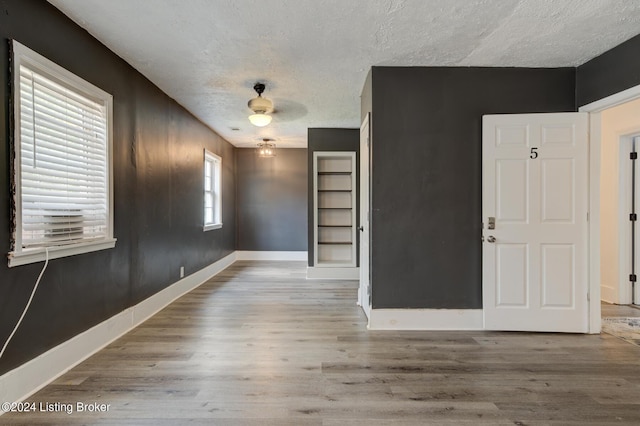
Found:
[358,114,371,318]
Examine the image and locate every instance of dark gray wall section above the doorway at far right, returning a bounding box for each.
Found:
[576,35,640,106]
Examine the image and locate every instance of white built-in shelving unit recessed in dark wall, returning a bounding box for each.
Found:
[313,152,356,267]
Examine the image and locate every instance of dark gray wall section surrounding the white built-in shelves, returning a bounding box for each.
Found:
[307,128,360,266]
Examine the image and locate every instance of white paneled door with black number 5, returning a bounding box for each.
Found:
[482,113,589,333]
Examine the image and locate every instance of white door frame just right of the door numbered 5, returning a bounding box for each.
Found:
[578,80,640,334]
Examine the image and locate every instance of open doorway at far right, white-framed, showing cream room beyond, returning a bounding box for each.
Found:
[580,86,640,333]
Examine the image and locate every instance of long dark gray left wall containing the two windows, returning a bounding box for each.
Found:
[0,0,236,374]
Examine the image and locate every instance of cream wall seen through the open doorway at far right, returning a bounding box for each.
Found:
[600,99,640,303]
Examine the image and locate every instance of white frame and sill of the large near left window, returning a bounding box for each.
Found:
[8,40,116,267]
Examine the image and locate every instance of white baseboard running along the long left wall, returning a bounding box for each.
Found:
[0,253,236,406]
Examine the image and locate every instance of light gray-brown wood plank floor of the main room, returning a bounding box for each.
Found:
[0,262,640,426]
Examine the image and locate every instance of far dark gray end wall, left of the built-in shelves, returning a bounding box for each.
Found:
[236,148,307,251]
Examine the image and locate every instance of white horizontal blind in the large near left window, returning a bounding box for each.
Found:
[20,66,107,248]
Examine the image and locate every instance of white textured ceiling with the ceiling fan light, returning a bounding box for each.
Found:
[49,0,640,147]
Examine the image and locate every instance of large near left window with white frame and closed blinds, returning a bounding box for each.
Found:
[9,41,115,266]
